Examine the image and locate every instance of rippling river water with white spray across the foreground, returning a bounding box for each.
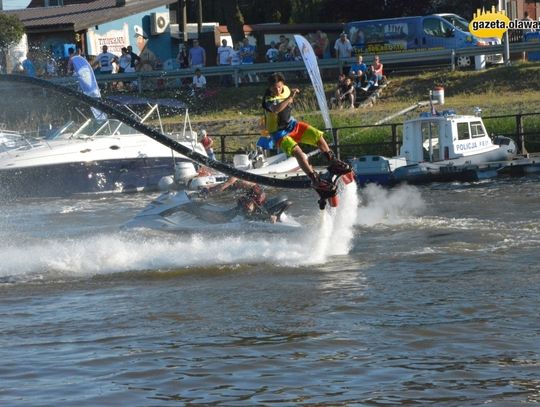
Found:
[0,177,540,407]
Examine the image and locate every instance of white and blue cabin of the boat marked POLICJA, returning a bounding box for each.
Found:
[400,111,498,164]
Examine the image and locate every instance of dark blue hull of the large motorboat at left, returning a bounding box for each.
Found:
[0,155,182,199]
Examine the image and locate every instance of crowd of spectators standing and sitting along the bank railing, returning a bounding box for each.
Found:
[11,30,384,108]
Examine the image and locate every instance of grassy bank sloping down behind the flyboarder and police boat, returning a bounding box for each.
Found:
[143,62,540,155]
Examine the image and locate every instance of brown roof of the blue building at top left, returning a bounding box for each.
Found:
[6,0,176,32]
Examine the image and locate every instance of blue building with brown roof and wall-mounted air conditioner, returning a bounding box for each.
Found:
[7,0,178,72]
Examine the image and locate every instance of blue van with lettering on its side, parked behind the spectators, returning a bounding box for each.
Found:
[345,14,502,67]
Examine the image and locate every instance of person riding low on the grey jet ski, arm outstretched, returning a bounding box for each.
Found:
[201,177,277,223]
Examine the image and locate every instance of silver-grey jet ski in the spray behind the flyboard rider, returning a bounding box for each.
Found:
[125,190,300,232]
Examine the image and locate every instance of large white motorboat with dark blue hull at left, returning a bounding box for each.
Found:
[0,112,206,199]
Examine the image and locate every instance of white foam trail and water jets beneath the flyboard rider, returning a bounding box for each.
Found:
[0,183,358,281]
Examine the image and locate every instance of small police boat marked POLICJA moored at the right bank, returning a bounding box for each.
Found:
[351,110,517,185]
